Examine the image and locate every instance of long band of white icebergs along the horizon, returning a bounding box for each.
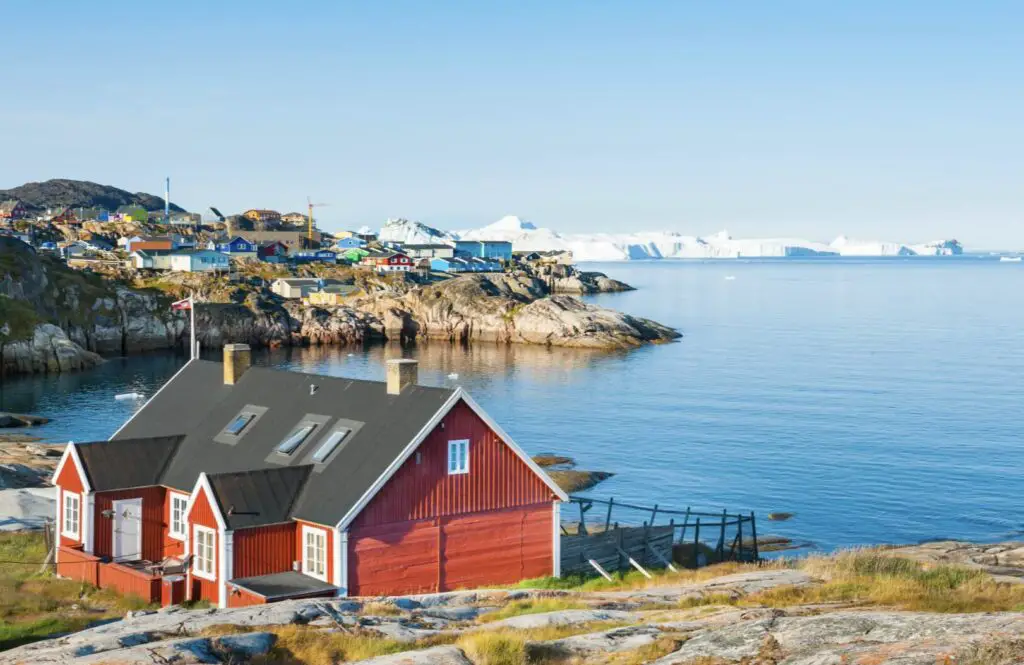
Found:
[372,215,964,261]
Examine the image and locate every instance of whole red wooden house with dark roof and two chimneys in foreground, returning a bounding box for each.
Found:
[53,344,567,607]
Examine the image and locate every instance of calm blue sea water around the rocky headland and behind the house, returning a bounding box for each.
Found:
[0,257,1024,548]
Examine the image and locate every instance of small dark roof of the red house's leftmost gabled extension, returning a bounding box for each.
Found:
[76,434,184,492]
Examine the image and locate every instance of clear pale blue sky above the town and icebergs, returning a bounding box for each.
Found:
[0,0,1024,247]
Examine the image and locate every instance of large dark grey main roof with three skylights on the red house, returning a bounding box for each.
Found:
[115,361,453,526]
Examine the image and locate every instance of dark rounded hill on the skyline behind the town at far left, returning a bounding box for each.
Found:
[0,178,185,212]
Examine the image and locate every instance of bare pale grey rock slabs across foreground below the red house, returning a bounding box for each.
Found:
[12,557,1024,665]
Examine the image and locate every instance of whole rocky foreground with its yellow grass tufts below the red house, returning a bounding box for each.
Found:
[6,543,1024,665]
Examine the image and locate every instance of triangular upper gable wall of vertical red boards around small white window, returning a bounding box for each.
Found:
[352,403,554,529]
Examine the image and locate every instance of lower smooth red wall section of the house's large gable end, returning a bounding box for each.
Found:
[348,502,554,595]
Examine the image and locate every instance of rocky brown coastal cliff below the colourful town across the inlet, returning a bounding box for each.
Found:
[0,238,680,375]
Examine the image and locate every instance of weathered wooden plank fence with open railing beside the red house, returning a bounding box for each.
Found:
[561,496,760,575]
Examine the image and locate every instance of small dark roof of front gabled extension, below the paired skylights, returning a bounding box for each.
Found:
[203,465,312,529]
